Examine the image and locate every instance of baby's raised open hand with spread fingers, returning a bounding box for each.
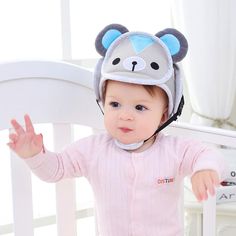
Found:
[8,115,43,158]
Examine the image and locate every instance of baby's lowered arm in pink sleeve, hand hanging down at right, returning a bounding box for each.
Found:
[177,139,226,201]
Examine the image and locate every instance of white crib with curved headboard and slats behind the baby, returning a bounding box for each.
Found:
[0,61,236,236]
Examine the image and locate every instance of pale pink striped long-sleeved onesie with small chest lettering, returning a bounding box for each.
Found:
[26,133,225,236]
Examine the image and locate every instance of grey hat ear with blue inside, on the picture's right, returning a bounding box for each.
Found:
[155,28,188,63]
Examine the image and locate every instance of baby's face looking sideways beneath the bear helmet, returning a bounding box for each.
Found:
[104,81,168,144]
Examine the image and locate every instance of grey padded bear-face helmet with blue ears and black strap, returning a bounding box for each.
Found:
[94,24,188,149]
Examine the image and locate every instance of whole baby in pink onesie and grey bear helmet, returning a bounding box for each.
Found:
[8,24,224,236]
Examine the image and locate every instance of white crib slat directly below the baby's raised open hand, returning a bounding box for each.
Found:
[11,153,34,236]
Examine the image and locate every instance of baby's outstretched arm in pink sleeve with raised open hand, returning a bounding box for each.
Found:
[8,115,89,182]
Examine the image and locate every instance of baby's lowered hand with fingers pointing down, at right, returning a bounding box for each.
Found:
[191,170,220,201]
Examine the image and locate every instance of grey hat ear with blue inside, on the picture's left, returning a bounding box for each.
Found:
[95,24,128,57]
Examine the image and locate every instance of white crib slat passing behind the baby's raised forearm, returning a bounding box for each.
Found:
[53,124,77,236]
